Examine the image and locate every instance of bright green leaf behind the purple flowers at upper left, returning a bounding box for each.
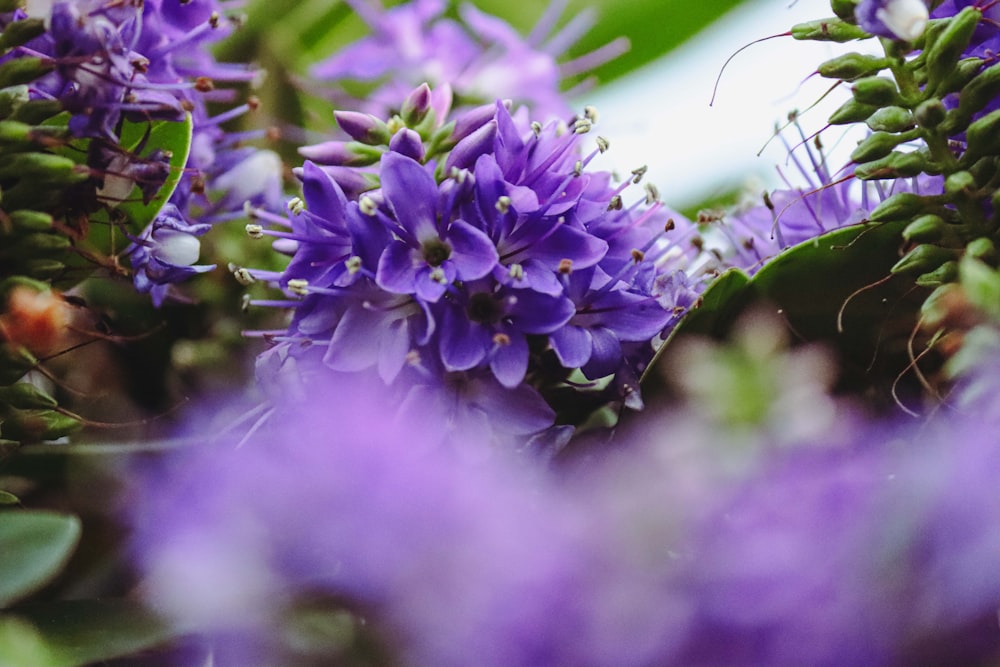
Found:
[118,114,193,233]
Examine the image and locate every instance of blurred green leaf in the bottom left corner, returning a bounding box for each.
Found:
[0,600,176,667]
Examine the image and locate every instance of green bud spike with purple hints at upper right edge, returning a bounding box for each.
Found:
[808,0,1000,300]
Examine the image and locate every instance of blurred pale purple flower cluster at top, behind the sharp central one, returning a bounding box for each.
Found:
[312,0,628,119]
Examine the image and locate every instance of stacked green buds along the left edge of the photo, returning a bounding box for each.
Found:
[0,15,90,440]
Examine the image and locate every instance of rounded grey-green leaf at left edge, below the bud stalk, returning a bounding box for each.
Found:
[0,510,80,612]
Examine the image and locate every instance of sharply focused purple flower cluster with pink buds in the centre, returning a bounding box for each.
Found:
[241,86,697,444]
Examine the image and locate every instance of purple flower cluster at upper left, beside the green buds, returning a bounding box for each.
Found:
[10,0,281,305]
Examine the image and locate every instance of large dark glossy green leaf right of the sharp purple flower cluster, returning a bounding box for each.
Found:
[642,221,928,404]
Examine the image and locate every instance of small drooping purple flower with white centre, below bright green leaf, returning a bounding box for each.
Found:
[125,204,215,306]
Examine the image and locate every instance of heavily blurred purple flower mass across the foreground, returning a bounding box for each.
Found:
[131,370,1000,666]
